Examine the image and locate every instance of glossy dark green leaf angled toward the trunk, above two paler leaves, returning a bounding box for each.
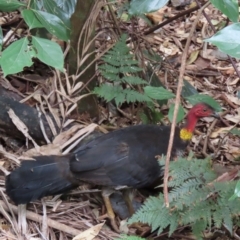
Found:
[34,10,70,41]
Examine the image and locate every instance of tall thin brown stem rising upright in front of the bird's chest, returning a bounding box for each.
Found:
[163,2,210,207]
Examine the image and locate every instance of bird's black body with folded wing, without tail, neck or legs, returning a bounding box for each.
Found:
[70,125,187,187]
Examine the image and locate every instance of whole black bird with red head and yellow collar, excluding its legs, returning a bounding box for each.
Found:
[6,103,216,204]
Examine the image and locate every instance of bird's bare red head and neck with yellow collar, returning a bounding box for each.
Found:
[180,103,218,140]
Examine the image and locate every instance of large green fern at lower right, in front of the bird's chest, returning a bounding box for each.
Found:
[130,159,240,239]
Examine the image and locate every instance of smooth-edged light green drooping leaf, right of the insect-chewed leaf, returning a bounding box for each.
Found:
[32,37,64,71]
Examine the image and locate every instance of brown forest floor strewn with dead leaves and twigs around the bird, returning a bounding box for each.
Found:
[0,1,240,240]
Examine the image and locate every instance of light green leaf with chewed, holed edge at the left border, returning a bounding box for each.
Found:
[0,37,36,76]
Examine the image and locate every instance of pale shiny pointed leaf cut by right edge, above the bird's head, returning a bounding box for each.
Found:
[205,23,240,59]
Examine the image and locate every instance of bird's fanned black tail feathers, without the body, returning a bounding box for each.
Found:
[5,156,76,204]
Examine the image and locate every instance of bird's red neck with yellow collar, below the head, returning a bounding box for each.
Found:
[180,112,198,141]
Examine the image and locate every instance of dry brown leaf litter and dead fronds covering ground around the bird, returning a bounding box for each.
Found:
[0,0,240,240]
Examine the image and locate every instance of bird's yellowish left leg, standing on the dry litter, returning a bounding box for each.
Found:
[102,188,120,233]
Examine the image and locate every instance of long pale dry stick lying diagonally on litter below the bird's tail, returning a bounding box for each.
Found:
[0,200,81,236]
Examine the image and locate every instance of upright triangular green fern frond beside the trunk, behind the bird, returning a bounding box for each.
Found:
[94,35,152,105]
